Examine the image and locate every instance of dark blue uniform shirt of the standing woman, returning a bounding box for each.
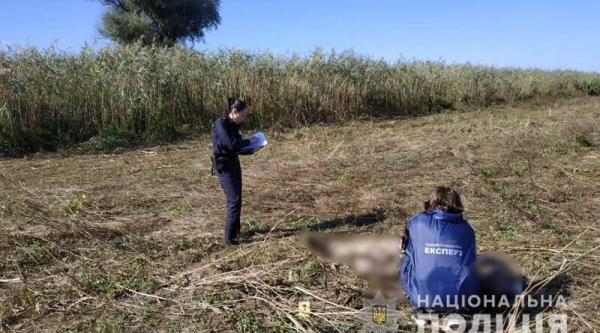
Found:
[212,117,252,158]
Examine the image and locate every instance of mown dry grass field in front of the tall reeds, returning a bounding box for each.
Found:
[0,97,600,332]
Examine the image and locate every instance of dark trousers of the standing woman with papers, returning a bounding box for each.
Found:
[217,159,242,244]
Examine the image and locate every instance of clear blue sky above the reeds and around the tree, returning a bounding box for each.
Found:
[0,0,600,71]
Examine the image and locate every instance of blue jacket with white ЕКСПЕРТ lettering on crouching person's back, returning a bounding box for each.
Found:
[400,210,478,310]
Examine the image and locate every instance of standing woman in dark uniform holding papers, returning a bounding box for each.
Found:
[212,98,261,245]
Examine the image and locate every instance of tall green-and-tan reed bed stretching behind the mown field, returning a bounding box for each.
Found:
[0,45,600,153]
